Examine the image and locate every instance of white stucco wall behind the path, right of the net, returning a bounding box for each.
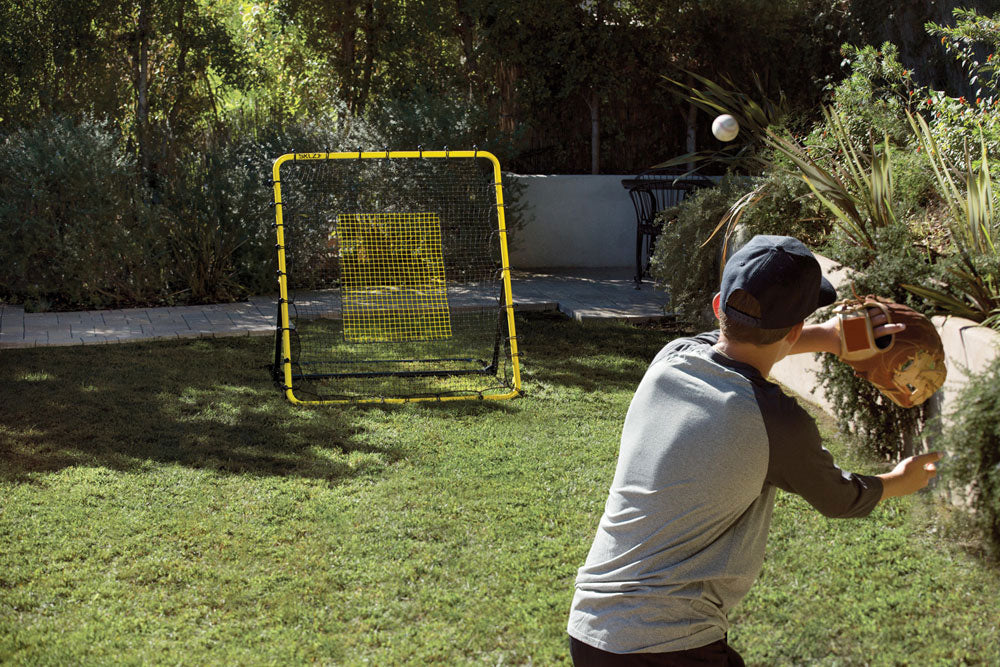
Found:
[504,174,636,269]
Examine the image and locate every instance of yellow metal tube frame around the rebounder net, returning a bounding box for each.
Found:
[272,150,521,405]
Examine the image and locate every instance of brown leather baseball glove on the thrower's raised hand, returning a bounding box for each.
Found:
[834,295,947,408]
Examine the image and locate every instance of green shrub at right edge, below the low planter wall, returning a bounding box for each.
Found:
[940,358,1000,554]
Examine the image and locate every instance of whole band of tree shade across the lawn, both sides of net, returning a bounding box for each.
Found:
[0,314,679,481]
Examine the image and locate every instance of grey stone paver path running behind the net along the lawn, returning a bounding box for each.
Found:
[0,268,667,348]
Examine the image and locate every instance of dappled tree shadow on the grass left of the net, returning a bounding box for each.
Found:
[0,338,403,481]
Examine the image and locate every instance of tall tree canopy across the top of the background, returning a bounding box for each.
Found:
[0,0,968,173]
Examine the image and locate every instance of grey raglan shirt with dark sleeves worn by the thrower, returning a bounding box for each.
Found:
[568,332,882,653]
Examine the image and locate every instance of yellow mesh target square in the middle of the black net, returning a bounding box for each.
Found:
[331,213,451,343]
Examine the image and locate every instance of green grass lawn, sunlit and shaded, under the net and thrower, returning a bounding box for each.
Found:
[0,315,1000,665]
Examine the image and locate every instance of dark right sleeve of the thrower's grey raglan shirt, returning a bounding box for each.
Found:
[757,385,882,518]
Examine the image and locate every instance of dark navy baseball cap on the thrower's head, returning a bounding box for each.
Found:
[719,234,837,329]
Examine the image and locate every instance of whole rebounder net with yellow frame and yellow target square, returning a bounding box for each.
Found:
[273,151,520,403]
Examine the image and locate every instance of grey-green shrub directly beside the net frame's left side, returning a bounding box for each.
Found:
[148,110,386,303]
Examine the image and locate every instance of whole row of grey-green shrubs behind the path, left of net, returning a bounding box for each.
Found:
[0,111,523,310]
